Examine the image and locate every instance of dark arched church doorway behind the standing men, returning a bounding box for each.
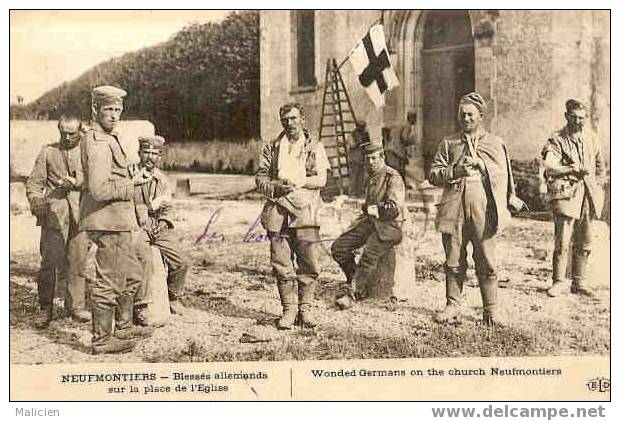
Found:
[416,10,475,174]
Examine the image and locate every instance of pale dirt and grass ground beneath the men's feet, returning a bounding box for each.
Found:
[10,192,610,364]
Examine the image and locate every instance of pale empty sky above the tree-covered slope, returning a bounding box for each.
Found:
[10,10,229,103]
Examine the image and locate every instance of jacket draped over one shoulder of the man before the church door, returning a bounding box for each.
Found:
[429,131,514,234]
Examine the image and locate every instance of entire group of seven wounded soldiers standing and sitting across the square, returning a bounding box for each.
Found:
[27,86,605,353]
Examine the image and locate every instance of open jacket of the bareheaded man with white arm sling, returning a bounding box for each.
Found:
[256,131,325,232]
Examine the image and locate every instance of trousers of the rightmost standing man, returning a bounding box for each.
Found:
[553,195,594,282]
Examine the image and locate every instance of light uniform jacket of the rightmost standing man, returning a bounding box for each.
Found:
[543,127,605,219]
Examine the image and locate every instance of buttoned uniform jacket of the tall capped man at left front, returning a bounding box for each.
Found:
[80,123,137,231]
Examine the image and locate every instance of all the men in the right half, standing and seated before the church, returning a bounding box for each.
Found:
[256,92,605,329]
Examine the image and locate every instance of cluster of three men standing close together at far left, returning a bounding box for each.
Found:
[26,86,189,354]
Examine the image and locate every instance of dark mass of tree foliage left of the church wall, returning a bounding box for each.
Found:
[17,11,260,142]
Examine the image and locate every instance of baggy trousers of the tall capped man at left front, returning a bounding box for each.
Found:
[87,231,143,310]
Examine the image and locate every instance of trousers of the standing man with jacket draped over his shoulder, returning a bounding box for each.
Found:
[441,180,496,278]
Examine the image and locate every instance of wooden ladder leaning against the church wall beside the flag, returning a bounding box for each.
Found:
[319,58,356,197]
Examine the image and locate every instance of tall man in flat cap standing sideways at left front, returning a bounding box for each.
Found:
[80,86,152,354]
